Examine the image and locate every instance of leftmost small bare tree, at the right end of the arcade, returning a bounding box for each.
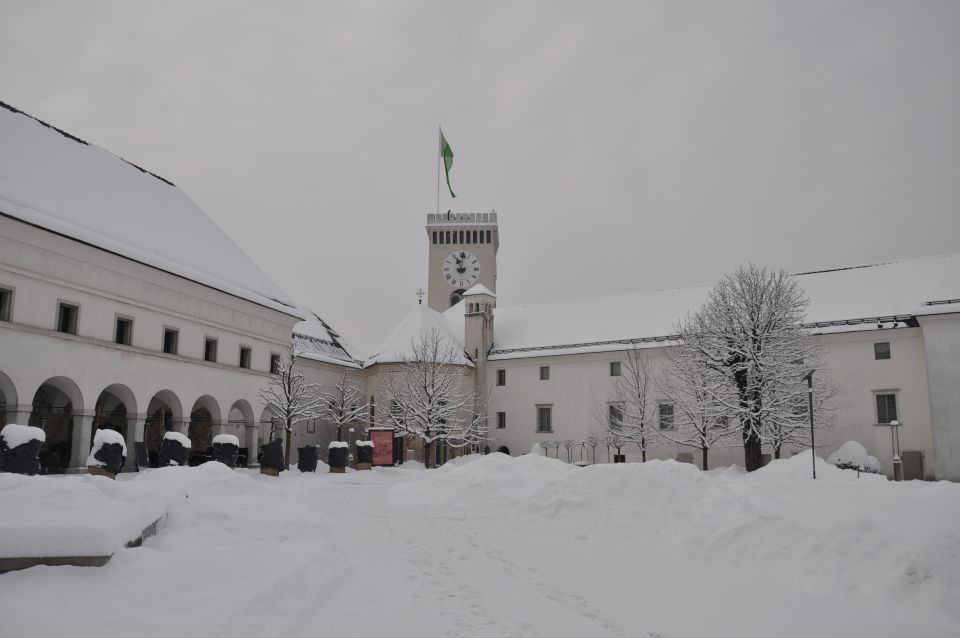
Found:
[259,341,321,467]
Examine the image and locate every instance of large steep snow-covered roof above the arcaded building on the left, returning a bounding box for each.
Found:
[0,102,296,315]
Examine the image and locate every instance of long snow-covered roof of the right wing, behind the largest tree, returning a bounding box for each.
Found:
[478,253,960,359]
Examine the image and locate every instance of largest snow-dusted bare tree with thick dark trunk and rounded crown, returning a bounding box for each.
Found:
[678,265,823,471]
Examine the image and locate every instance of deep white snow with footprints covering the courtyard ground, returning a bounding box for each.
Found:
[0,454,960,638]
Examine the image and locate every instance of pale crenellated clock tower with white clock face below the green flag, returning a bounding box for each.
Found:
[427,212,500,312]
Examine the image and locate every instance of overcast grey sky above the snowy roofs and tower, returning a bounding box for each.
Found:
[0,0,960,354]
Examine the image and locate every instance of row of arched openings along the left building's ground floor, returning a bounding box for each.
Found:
[0,371,270,474]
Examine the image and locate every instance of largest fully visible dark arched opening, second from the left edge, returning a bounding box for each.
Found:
[27,377,84,474]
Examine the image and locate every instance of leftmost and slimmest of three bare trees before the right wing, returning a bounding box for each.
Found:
[596,348,656,462]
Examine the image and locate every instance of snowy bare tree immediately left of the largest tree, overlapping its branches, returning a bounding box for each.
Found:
[657,347,736,470]
